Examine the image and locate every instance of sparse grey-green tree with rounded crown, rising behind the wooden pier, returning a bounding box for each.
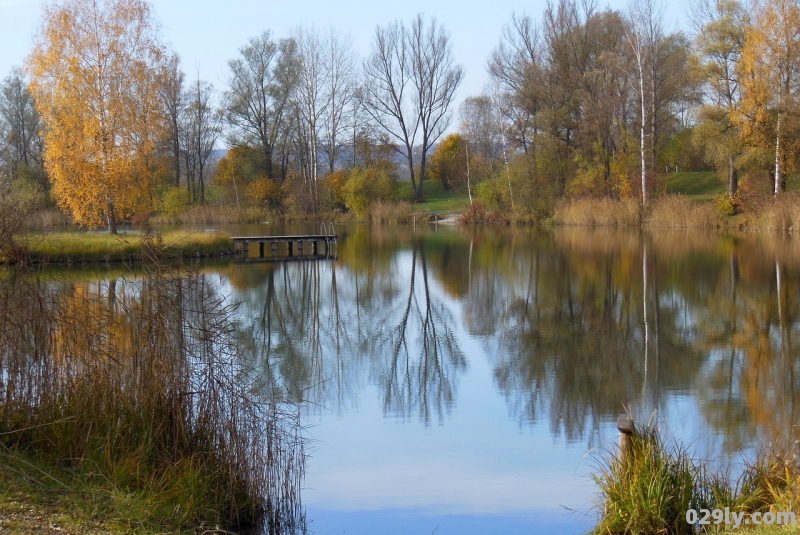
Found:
[224,31,297,178]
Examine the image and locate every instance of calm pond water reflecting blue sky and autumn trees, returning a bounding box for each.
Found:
[40,227,800,535]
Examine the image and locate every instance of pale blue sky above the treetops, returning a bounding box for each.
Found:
[0,0,684,114]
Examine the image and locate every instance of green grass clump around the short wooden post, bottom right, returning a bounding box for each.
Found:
[593,426,800,535]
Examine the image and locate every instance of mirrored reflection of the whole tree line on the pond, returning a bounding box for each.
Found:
[229,227,800,458]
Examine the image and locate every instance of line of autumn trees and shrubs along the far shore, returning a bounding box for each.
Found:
[0,0,800,232]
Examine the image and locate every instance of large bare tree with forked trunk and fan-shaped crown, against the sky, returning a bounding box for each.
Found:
[364,15,464,200]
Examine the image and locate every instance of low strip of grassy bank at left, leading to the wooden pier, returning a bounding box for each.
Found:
[5,231,233,264]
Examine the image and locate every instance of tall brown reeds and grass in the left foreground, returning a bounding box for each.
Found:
[0,240,305,533]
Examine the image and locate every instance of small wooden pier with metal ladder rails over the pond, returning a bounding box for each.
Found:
[231,223,339,262]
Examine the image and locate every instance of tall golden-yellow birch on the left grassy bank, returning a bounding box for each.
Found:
[27,0,167,233]
